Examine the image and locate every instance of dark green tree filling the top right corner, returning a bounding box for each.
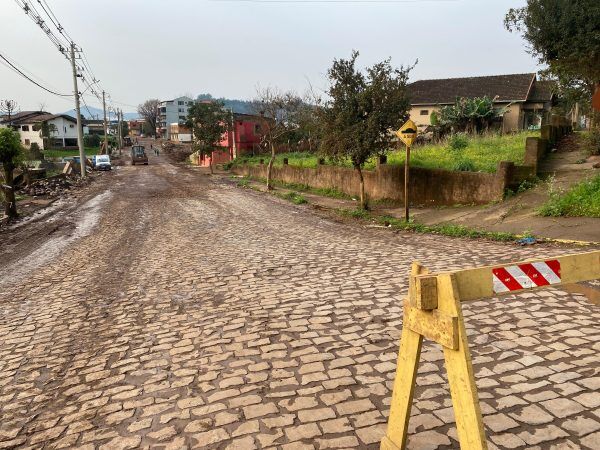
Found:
[504,0,600,125]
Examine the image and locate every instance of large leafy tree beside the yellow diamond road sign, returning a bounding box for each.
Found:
[321,51,412,209]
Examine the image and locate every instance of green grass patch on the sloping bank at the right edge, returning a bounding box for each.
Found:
[539,175,600,217]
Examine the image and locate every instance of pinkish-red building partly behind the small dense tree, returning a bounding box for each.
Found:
[198,113,264,167]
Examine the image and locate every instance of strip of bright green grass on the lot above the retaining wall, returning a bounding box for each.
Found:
[235,131,539,173]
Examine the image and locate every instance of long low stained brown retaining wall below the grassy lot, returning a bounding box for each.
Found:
[232,163,514,205]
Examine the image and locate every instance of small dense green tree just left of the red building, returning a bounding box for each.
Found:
[185,101,231,174]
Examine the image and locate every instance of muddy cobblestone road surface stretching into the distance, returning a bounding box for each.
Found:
[0,156,600,450]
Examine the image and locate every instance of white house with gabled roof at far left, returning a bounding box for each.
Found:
[0,111,88,150]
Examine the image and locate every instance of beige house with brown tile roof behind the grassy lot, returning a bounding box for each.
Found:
[407,73,554,132]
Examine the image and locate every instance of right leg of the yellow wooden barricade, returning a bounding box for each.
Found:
[438,275,487,450]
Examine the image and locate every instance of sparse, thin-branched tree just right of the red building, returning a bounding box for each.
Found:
[253,87,303,190]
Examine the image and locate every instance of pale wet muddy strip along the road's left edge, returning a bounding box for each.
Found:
[0,191,112,285]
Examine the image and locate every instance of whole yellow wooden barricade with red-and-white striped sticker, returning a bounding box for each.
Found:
[381,251,600,450]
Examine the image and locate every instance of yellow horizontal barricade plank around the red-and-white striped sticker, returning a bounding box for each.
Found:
[437,251,600,302]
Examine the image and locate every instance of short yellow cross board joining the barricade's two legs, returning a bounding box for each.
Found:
[403,302,458,350]
